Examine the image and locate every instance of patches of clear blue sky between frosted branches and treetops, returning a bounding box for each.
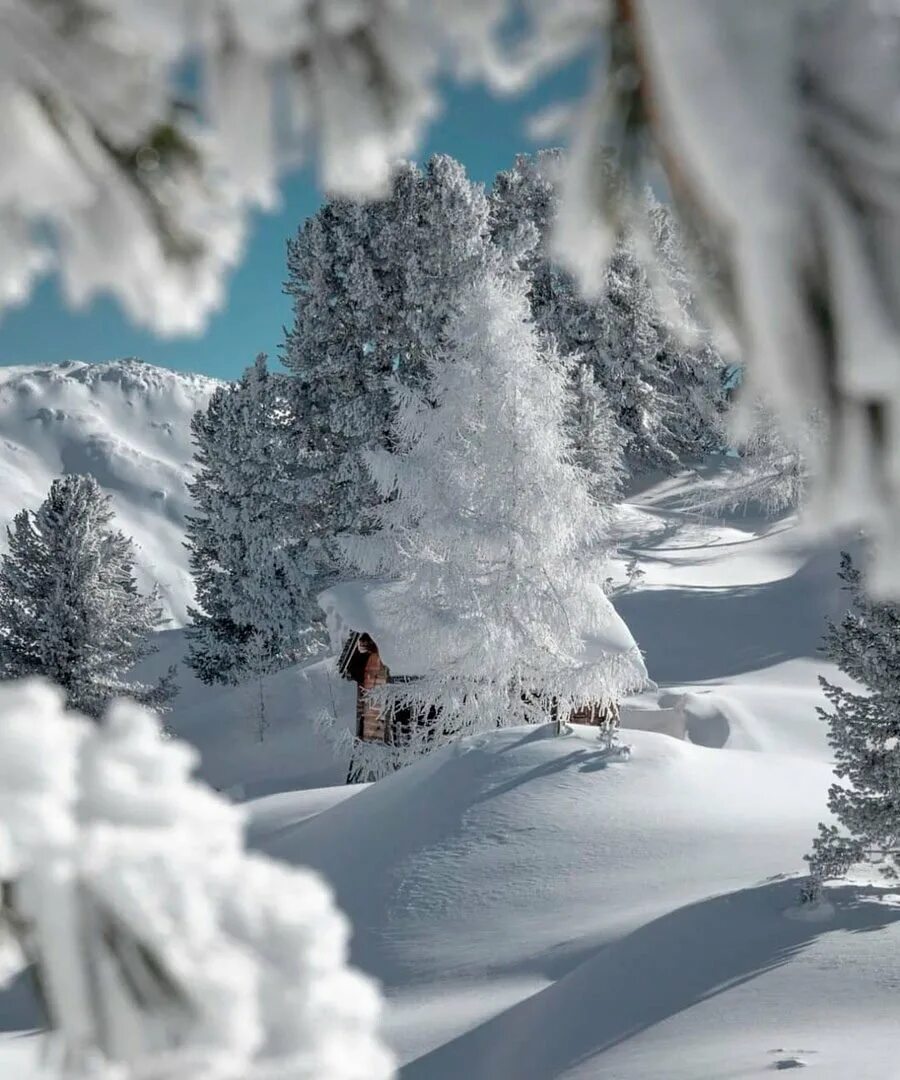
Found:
[0,66,586,378]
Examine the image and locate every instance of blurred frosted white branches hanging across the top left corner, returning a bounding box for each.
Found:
[0,0,435,334]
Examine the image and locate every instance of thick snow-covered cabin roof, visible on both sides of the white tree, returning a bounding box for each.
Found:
[319,581,647,689]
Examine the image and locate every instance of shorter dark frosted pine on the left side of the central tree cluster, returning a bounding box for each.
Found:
[186,355,320,686]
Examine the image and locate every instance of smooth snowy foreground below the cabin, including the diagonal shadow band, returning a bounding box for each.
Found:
[258,726,900,1080]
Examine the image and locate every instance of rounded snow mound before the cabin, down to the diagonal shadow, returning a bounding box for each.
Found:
[263,725,830,985]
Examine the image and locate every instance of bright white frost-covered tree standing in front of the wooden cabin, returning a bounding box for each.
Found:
[344,265,644,764]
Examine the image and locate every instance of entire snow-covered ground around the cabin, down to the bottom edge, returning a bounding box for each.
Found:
[0,368,900,1080]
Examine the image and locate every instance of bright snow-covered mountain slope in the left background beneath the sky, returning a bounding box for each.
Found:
[0,360,217,624]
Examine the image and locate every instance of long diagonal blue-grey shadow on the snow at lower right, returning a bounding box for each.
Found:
[402,879,900,1080]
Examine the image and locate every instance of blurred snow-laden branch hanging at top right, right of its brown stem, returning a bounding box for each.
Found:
[610,0,900,595]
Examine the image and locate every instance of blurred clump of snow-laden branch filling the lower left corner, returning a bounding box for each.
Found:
[0,681,392,1080]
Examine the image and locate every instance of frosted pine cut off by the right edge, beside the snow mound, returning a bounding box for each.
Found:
[804,552,900,899]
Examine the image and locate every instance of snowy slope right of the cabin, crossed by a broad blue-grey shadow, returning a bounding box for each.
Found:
[617,475,857,760]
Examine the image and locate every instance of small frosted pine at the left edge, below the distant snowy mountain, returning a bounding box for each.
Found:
[0,475,176,717]
